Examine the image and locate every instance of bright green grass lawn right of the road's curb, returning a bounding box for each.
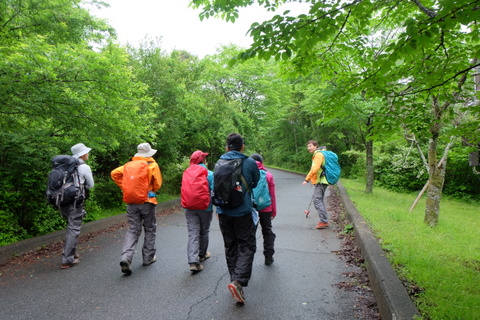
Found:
[342,179,480,320]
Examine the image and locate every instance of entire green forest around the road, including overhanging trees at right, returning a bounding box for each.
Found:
[0,0,480,245]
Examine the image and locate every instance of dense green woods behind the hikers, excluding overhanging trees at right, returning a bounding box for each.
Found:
[0,0,480,245]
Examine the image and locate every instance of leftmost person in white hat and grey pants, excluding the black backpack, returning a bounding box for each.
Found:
[60,143,94,269]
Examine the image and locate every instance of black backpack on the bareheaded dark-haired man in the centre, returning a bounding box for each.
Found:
[212,159,248,209]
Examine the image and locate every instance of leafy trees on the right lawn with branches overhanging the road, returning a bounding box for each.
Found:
[191,0,480,226]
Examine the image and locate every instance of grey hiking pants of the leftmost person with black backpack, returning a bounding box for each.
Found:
[60,204,86,264]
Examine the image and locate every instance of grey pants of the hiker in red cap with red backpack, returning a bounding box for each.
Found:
[185,209,213,263]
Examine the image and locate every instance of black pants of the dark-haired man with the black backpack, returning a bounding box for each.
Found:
[218,214,257,287]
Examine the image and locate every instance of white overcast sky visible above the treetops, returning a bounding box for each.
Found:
[90,0,308,58]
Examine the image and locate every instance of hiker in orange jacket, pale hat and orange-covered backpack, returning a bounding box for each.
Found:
[110,143,162,275]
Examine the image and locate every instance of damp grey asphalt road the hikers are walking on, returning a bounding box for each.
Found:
[0,170,357,320]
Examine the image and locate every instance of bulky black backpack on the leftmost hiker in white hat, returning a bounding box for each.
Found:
[46,155,85,208]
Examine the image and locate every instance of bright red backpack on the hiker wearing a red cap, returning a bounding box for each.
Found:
[180,164,210,210]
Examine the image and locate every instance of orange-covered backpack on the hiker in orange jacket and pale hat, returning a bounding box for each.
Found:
[122,160,150,204]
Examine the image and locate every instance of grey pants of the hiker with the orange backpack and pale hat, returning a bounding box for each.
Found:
[121,202,157,262]
